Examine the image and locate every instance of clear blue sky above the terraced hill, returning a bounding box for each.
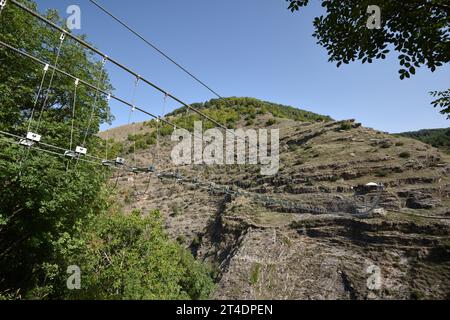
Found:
[37,0,450,132]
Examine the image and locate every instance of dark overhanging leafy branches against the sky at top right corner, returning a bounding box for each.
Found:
[286,0,450,114]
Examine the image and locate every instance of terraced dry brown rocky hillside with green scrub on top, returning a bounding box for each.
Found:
[101,98,450,299]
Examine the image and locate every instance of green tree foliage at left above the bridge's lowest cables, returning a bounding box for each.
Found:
[0,1,112,136]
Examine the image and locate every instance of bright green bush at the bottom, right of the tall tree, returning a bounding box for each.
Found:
[67,211,213,299]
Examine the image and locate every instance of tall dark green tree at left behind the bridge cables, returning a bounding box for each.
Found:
[0,1,111,297]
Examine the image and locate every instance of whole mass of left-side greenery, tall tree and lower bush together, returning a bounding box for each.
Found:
[0,0,212,299]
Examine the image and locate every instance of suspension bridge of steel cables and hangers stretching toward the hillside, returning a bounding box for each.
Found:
[0,0,383,217]
